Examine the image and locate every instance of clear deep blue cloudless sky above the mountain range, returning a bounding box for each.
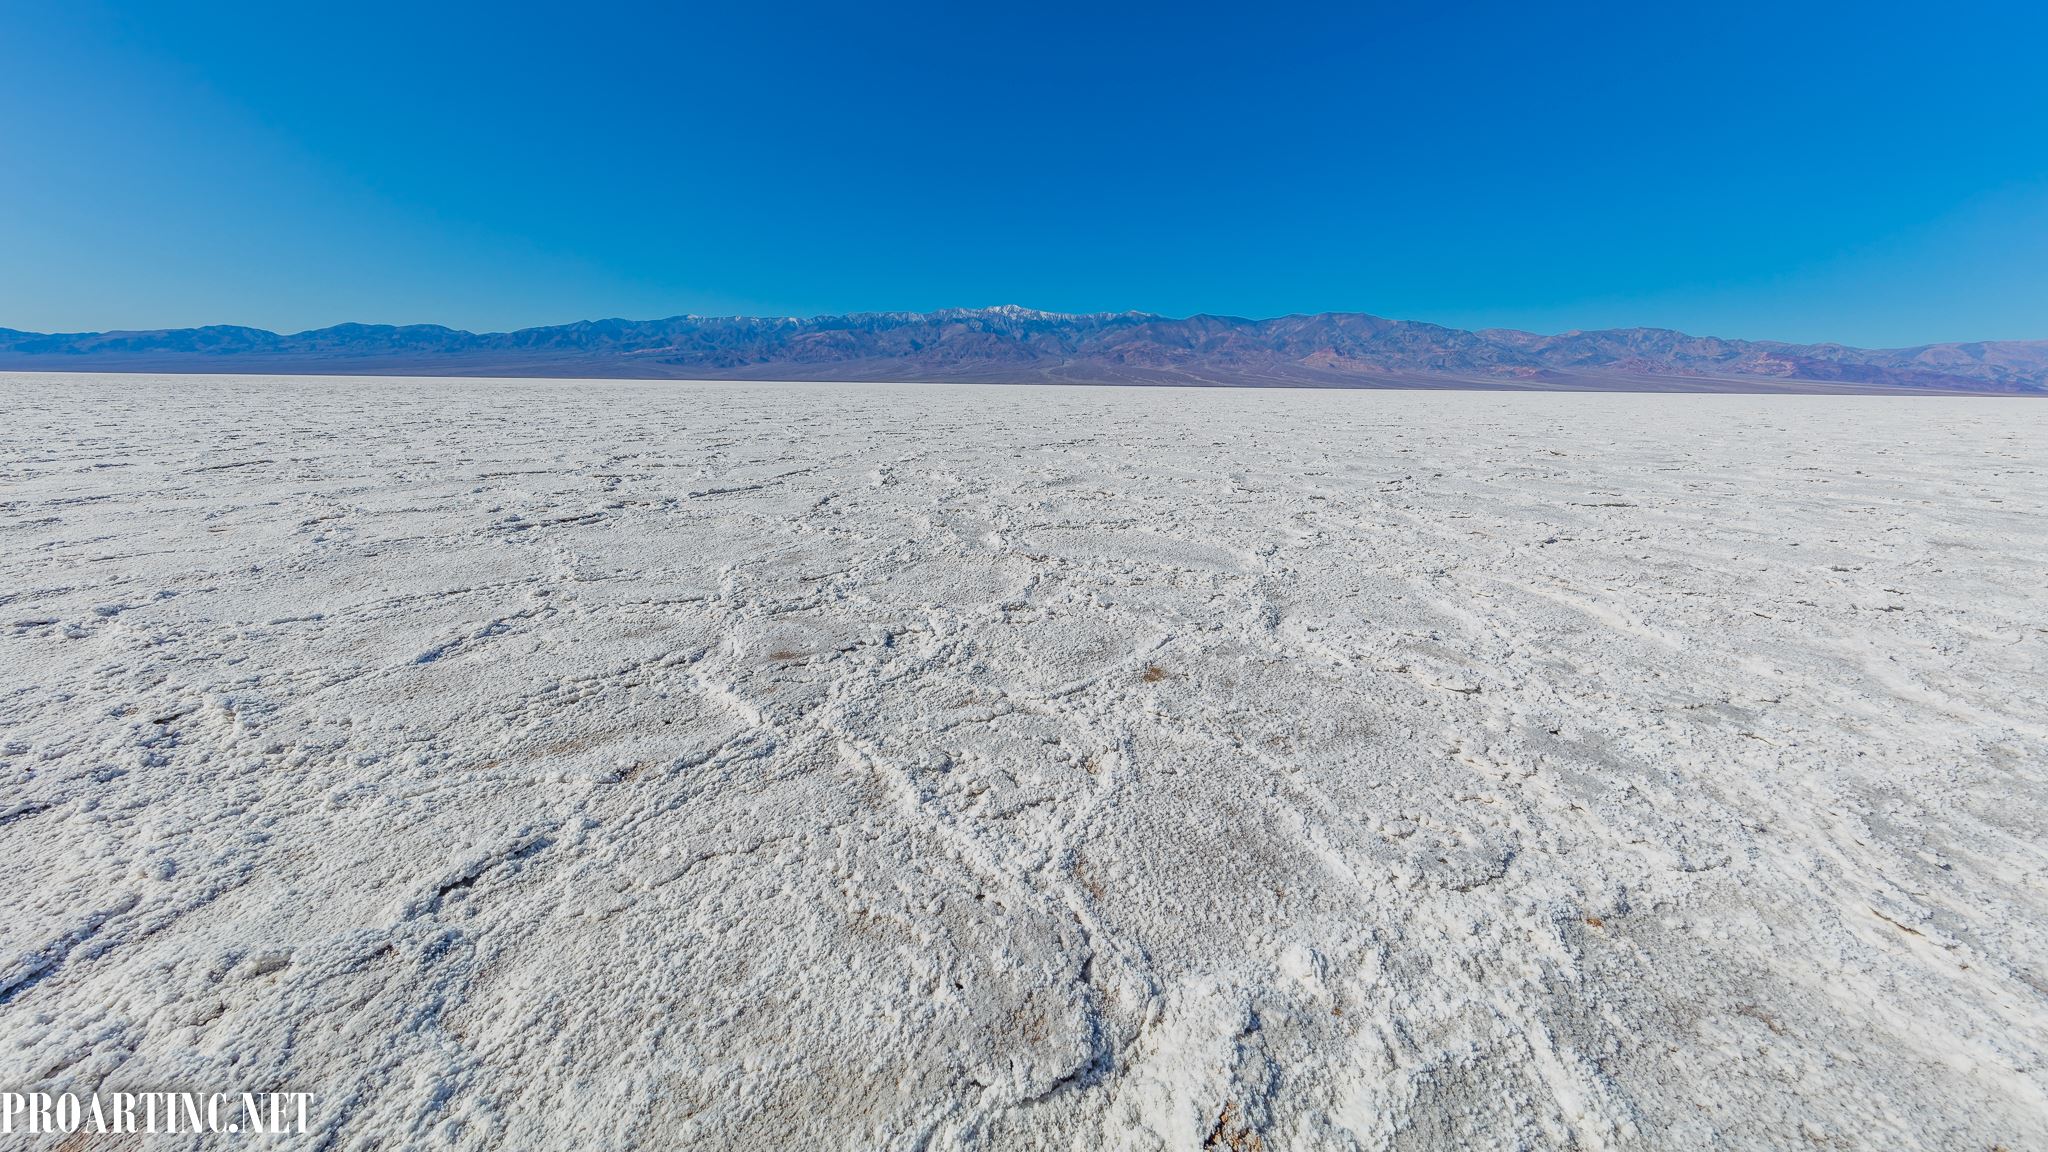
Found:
[0,0,2048,344]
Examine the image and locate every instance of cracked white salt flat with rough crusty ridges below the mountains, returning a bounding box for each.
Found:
[0,375,2048,1152]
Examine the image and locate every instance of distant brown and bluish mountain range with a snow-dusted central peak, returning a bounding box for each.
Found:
[0,305,2048,394]
